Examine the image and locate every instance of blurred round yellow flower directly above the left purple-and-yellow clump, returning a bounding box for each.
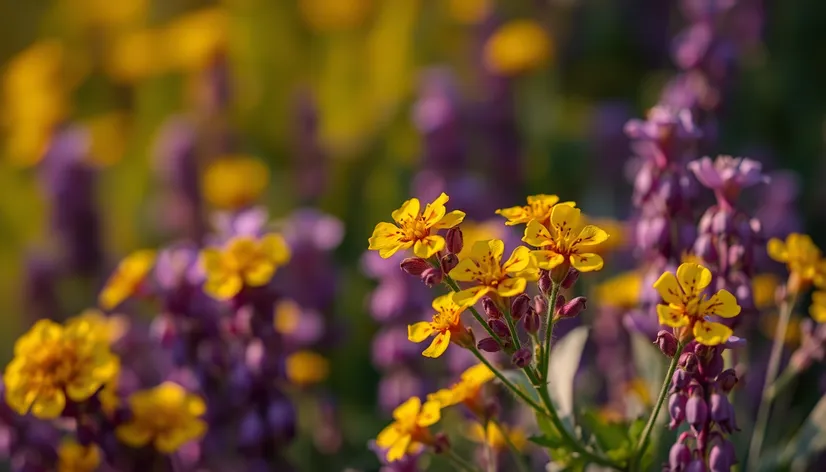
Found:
[202,156,270,210]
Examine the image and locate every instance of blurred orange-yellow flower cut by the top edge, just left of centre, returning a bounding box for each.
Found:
[298,0,373,33]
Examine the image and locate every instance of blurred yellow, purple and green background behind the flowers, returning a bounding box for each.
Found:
[0,0,826,470]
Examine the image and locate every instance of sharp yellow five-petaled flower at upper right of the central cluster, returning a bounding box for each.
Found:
[522,205,608,272]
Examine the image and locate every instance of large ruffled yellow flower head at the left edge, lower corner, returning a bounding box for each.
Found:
[3,318,120,419]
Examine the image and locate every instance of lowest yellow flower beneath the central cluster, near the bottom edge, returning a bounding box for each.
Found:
[376,397,442,462]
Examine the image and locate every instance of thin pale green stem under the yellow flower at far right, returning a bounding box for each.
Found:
[746,293,797,467]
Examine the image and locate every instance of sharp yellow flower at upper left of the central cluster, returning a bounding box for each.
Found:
[369,193,465,259]
